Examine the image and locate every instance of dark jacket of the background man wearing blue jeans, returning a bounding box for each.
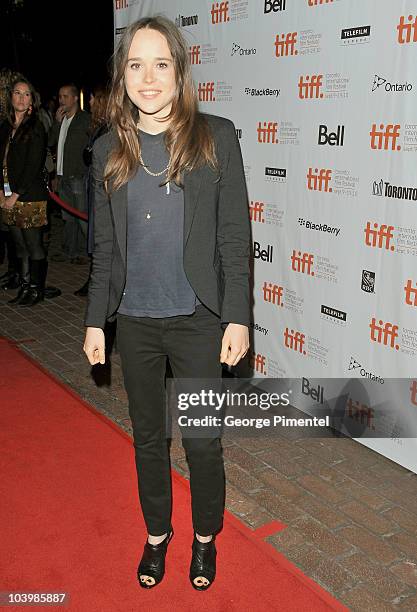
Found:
[48,110,91,178]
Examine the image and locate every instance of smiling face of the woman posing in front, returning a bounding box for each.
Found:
[125,28,176,118]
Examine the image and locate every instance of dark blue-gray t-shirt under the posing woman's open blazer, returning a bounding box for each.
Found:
[118,131,200,318]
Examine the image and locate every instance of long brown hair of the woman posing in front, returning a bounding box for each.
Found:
[104,16,218,191]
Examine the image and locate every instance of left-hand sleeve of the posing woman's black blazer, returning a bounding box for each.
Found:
[84,141,114,329]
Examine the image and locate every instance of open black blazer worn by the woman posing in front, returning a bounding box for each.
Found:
[85,110,250,328]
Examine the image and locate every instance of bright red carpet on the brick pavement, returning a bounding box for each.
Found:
[0,339,346,612]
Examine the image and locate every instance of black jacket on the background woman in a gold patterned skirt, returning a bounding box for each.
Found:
[0,118,48,202]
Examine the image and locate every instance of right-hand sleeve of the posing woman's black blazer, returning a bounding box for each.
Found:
[216,120,250,327]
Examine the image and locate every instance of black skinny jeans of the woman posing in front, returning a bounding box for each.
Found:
[117,305,225,536]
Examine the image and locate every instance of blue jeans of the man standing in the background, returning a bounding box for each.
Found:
[58,175,88,259]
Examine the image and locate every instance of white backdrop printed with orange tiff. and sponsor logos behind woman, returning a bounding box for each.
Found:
[114,0,417,471]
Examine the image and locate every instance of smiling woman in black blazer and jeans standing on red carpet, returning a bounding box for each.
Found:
[84,17,250,590]
